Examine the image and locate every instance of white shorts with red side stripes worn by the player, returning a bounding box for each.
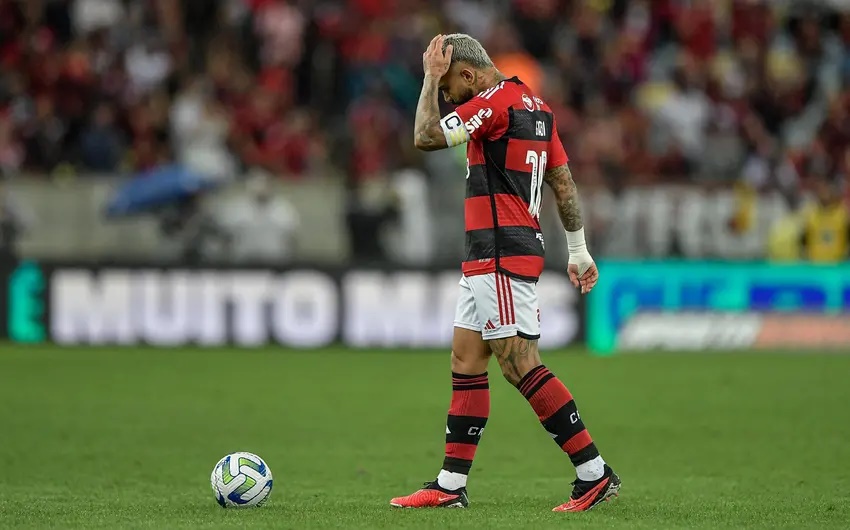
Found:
[454,272,540,340]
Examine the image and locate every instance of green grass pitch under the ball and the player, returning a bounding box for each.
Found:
[0,345,850,529]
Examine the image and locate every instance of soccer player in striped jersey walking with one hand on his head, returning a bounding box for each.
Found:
[390,34,620,512]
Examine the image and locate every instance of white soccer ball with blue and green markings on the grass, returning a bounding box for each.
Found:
[210,453,273,508]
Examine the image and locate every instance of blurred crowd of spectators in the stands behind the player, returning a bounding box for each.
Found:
[0,0,850,262]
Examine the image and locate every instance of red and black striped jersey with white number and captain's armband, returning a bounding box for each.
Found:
[440,77,568,281]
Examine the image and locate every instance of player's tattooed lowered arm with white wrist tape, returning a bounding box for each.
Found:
[543,163,599,294]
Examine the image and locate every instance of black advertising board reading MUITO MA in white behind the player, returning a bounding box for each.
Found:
[2,261,584,348]
